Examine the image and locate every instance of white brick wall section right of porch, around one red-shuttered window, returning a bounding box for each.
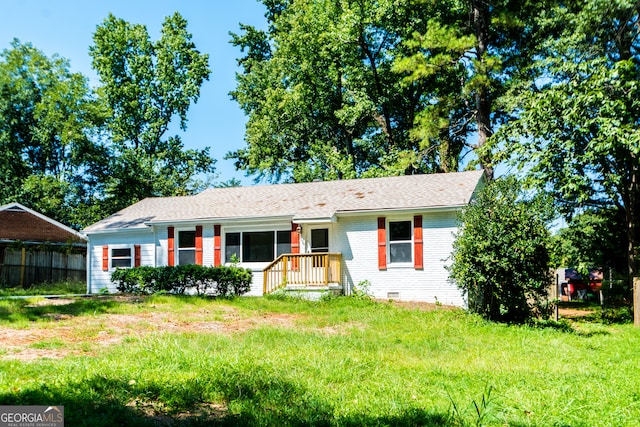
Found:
[334,212,465,306]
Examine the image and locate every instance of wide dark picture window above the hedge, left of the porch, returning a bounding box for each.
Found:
[224,231,291,262]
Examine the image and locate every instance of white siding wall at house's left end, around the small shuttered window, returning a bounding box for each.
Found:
[87,229,156,294]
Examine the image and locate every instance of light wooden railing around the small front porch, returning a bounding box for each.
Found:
[263,252,341,295]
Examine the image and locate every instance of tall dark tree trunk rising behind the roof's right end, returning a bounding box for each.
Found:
[471,0,493,179]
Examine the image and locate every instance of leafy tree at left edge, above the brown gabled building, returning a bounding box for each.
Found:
[0,40,106,226]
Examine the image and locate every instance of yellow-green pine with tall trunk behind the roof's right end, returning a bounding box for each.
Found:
[395,0,551,177]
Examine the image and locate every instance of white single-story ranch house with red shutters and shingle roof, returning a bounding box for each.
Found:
[84,171,485,306]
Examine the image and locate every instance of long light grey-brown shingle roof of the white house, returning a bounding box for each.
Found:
[84,171,484,234]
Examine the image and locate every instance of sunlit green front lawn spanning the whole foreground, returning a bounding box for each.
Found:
[0,296,640,426]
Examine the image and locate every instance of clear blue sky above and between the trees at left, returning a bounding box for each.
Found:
[0,0,266,185]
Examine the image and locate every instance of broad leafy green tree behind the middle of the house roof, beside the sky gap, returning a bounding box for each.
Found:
[229,0,460,181]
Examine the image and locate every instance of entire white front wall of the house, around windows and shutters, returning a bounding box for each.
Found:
[87,211,465,306]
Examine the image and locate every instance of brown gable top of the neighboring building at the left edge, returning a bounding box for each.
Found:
[0,203,86,244]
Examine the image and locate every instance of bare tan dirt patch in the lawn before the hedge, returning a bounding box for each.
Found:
[0,299,299,361]
